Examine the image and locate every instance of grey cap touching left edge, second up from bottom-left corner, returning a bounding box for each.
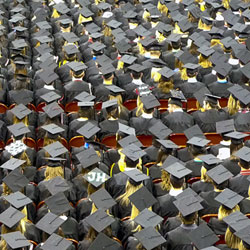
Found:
[0,206,25,228]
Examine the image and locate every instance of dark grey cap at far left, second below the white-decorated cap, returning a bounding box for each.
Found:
[3,169,29,192]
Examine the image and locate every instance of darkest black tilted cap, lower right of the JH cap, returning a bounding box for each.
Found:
[129,186,157,211]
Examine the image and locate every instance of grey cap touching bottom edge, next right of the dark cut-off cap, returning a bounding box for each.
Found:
[134,227,166,250]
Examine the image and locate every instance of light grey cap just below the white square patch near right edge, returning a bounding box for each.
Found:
[206,164,233,185]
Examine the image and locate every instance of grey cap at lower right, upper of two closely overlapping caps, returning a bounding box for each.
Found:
[173,195,203,216]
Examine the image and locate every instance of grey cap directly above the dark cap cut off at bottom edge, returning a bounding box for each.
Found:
[85,209,115,233]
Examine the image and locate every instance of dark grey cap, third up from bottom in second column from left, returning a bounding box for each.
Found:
[44,192,72,215]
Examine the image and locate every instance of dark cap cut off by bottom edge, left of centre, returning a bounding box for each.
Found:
[88,233,121,250]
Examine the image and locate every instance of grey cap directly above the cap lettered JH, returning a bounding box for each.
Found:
[76,148,101,168]
